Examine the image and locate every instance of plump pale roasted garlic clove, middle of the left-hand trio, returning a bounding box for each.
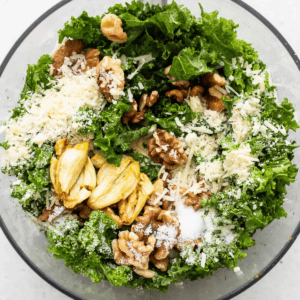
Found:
[56,142,89,198]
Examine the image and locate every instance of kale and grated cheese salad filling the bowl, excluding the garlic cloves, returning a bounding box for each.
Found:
[1,0,299,292]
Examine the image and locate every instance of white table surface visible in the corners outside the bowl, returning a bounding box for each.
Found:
[0,0,300,300]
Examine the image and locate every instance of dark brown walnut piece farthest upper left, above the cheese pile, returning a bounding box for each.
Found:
[53,40,84,76]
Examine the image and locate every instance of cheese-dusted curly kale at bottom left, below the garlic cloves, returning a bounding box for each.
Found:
[46,210,132,286]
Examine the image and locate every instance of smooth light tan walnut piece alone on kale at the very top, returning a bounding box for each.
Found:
[101,14,127,44]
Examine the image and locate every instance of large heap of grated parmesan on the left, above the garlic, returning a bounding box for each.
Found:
[2,63,104,167]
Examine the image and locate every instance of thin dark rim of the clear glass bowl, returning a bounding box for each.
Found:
[0,0,300,300]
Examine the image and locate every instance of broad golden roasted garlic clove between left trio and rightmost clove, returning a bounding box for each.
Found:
[88,161,140,209]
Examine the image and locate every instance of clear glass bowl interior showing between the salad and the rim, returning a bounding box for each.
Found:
[0,0,300,300]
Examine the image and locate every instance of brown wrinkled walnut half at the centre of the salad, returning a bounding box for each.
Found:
[147,129,187,170]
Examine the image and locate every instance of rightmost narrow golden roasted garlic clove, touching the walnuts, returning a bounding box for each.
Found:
[118,173,154,225]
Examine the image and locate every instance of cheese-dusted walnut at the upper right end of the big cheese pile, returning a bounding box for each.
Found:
[96,56,125,102]
